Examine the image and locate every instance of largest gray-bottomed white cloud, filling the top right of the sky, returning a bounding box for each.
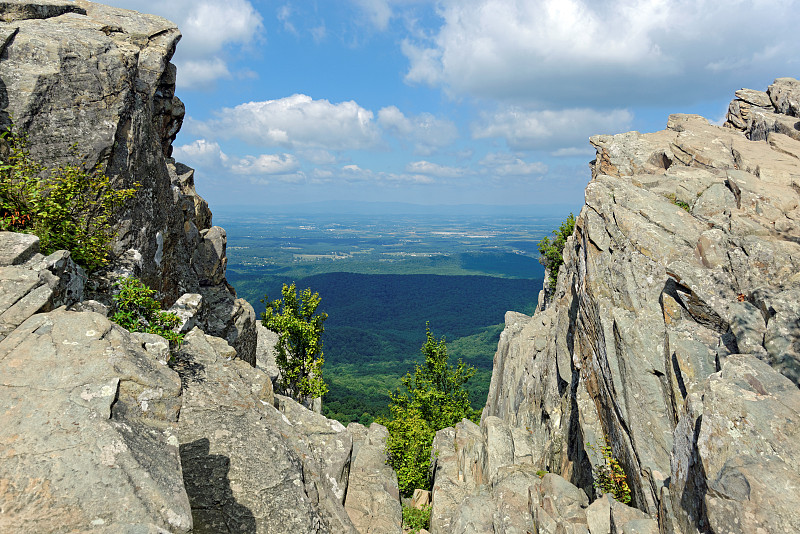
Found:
[402,0,800,107]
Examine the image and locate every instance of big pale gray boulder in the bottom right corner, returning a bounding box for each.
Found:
[671,355,800,532]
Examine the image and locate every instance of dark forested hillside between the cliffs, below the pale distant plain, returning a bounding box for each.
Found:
[229,271,542,424]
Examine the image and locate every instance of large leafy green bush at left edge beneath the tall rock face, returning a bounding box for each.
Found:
[0,131,138,271]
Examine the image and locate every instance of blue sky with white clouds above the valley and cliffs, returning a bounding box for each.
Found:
[104,0,800,210]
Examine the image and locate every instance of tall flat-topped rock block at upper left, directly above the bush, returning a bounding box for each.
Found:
[0,0,184,300]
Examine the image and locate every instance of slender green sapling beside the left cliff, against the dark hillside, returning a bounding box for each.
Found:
[261,282,328,403]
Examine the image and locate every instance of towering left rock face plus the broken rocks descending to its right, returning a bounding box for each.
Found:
[0,0,257,365]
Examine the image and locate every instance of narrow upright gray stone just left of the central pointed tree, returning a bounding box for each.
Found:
[344,423,403,534]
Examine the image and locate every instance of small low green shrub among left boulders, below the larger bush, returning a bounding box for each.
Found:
[111,276,183,350]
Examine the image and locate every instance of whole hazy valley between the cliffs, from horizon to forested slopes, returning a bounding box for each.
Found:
[216,206,563,424]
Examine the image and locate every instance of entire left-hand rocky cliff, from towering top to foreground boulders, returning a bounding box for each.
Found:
[0,0,401,534]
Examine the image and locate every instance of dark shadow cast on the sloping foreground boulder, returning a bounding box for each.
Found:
[180,438,256,534]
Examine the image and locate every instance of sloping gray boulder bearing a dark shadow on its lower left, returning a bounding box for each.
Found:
[175,329,355,533]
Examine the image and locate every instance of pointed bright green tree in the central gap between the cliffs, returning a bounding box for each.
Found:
[380,325,480,495]
